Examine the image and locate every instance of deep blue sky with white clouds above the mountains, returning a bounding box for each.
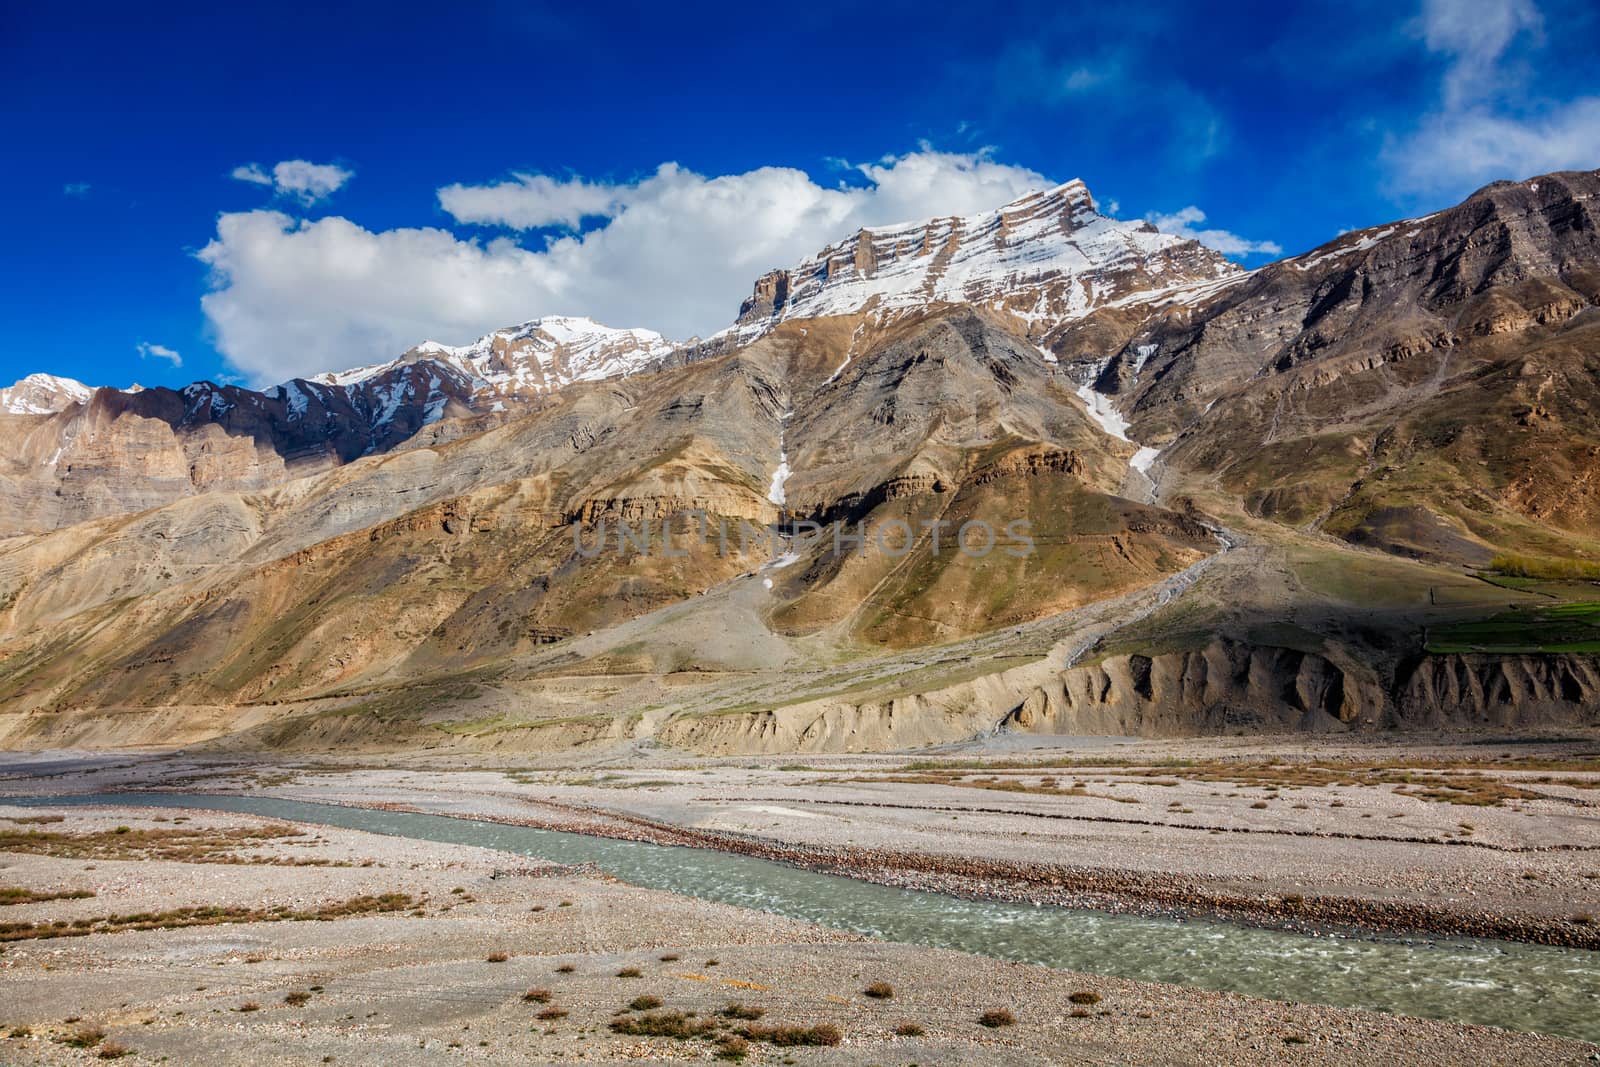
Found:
[0,0,1600,386]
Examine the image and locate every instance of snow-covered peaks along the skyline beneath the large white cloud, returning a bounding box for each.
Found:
[0,181,1248,441]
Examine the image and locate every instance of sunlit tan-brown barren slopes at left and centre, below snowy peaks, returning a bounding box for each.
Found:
[0,300,1213,735]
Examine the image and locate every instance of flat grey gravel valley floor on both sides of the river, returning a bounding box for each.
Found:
[0,731,1600,1064]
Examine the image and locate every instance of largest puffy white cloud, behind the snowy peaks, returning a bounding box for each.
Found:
[198,146,1053,384]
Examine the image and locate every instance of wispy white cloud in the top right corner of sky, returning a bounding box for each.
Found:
[1384,0,1600,197]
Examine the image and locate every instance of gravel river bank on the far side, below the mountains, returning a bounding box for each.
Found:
[12,733,1600,949]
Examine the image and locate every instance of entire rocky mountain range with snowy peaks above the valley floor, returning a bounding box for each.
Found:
[0,173,1600,752]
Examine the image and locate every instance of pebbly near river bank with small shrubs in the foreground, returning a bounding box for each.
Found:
[0,805,1597,1064]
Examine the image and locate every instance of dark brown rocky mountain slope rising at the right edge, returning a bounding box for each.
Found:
[1051,171,1600,563]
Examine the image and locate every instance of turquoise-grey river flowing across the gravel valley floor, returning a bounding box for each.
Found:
[12,793,1600,1041]
